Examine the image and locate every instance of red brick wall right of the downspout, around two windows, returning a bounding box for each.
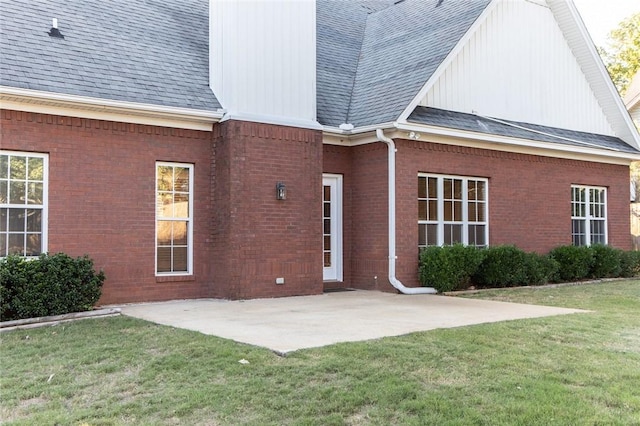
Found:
[396,140,631,286]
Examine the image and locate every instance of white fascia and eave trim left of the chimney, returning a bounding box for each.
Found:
[0,86,223,131]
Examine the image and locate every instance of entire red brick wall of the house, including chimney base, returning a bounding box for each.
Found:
[5,110,631,304]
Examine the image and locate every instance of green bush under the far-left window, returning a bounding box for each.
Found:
[0,253,105,321]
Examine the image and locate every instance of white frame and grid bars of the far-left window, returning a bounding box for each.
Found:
[0,150,49,258]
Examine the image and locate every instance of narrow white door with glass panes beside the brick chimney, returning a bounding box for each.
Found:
[322,174,342,281]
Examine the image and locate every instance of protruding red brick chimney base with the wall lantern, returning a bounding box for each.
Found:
[211,121,322,299]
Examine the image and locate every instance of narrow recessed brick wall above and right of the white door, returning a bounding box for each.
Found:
[322,145,353,290]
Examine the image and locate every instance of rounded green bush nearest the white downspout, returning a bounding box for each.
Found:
[418,244,484,292]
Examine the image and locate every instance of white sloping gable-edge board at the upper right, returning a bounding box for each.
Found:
[547,0,640,149]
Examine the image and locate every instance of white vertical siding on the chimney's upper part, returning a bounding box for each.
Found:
[209,0,316,121]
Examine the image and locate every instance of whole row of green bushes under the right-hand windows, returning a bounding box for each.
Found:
[418,244,640,292]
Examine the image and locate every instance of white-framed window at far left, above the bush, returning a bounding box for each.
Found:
[0,151,48,257]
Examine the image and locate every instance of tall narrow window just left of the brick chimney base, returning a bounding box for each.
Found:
[156,163,193,275]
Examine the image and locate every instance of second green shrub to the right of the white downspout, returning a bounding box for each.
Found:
[472,246,528,288]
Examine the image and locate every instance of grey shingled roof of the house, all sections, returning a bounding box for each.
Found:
[0,0,636,156]
